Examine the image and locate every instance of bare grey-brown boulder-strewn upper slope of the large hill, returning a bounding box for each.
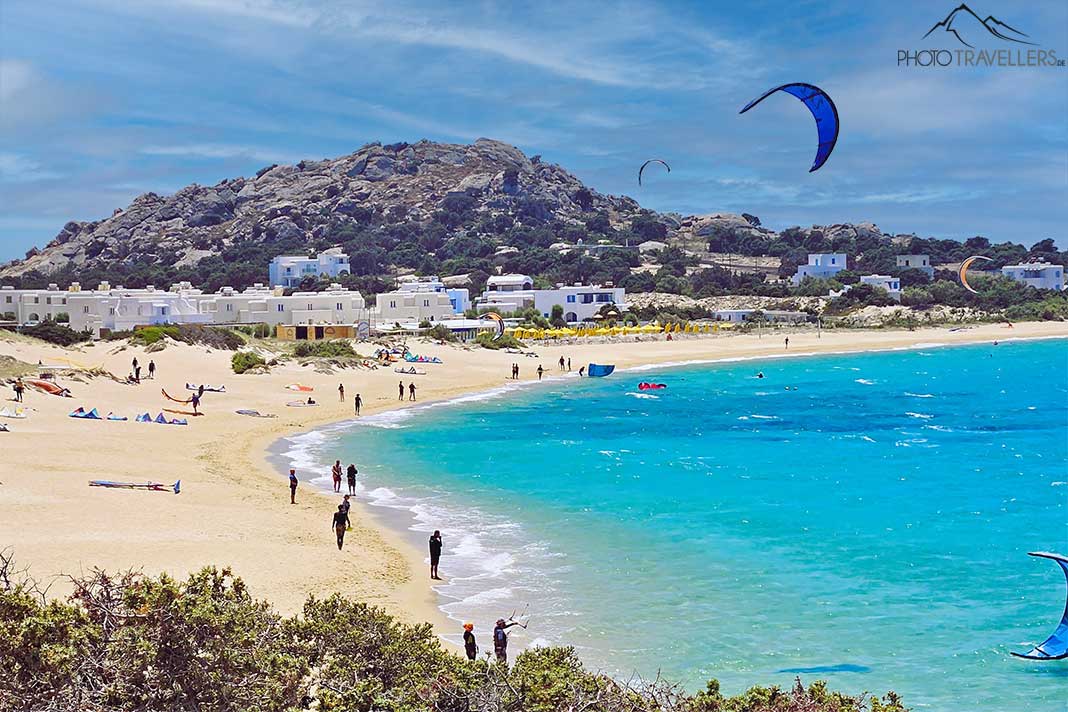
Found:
[0,139,640,276]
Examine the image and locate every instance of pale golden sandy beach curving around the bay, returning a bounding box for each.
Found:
[0,322,1068,631]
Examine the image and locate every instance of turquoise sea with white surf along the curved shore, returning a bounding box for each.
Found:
[286,339,1068,711]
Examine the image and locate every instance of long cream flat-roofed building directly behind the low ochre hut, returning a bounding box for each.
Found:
[202,284,370,327]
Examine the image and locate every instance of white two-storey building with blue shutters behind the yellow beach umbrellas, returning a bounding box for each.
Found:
[475,274,627,323]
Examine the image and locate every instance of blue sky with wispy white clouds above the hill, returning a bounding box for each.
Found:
[0,0,1068,260]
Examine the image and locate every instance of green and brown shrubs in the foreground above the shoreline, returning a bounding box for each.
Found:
[0,555,905,712]
